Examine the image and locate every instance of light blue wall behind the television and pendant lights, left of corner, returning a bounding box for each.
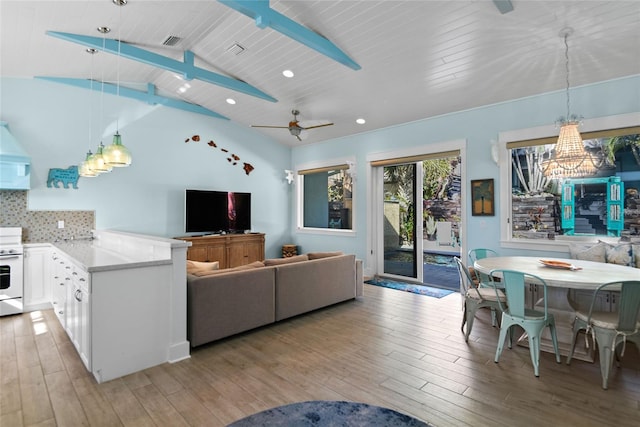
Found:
[0,78,291,257]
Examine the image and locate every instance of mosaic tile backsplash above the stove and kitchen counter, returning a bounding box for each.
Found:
[0,190,96,243]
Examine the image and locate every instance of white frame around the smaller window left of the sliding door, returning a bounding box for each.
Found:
[294,157,357,237]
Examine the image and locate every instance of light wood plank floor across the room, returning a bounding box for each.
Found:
[0,285,640,427]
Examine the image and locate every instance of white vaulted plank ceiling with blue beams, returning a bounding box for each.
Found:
[0,0,640,146]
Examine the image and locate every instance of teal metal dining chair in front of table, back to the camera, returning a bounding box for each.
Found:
[489,269,560,377]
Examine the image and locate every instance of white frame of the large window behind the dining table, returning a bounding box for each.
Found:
[497,113,640,253]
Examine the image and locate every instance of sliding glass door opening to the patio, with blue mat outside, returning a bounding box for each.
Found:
[372,150,462,287]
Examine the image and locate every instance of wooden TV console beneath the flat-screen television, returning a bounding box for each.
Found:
[177,233,264,268]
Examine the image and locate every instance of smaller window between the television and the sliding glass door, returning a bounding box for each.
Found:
[298,163,353,231]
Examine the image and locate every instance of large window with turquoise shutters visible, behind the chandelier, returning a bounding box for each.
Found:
[501,119,640,247]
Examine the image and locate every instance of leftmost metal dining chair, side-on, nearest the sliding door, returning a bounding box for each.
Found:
[453,257,507,342]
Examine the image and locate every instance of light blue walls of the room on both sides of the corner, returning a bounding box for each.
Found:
[5,75,640,259]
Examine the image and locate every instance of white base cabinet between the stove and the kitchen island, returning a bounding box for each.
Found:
[24,245,53,311]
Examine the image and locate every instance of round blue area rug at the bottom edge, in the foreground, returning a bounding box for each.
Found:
[228,400,429,427]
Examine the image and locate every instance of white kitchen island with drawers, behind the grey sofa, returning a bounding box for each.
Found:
[51,230,190,383]
